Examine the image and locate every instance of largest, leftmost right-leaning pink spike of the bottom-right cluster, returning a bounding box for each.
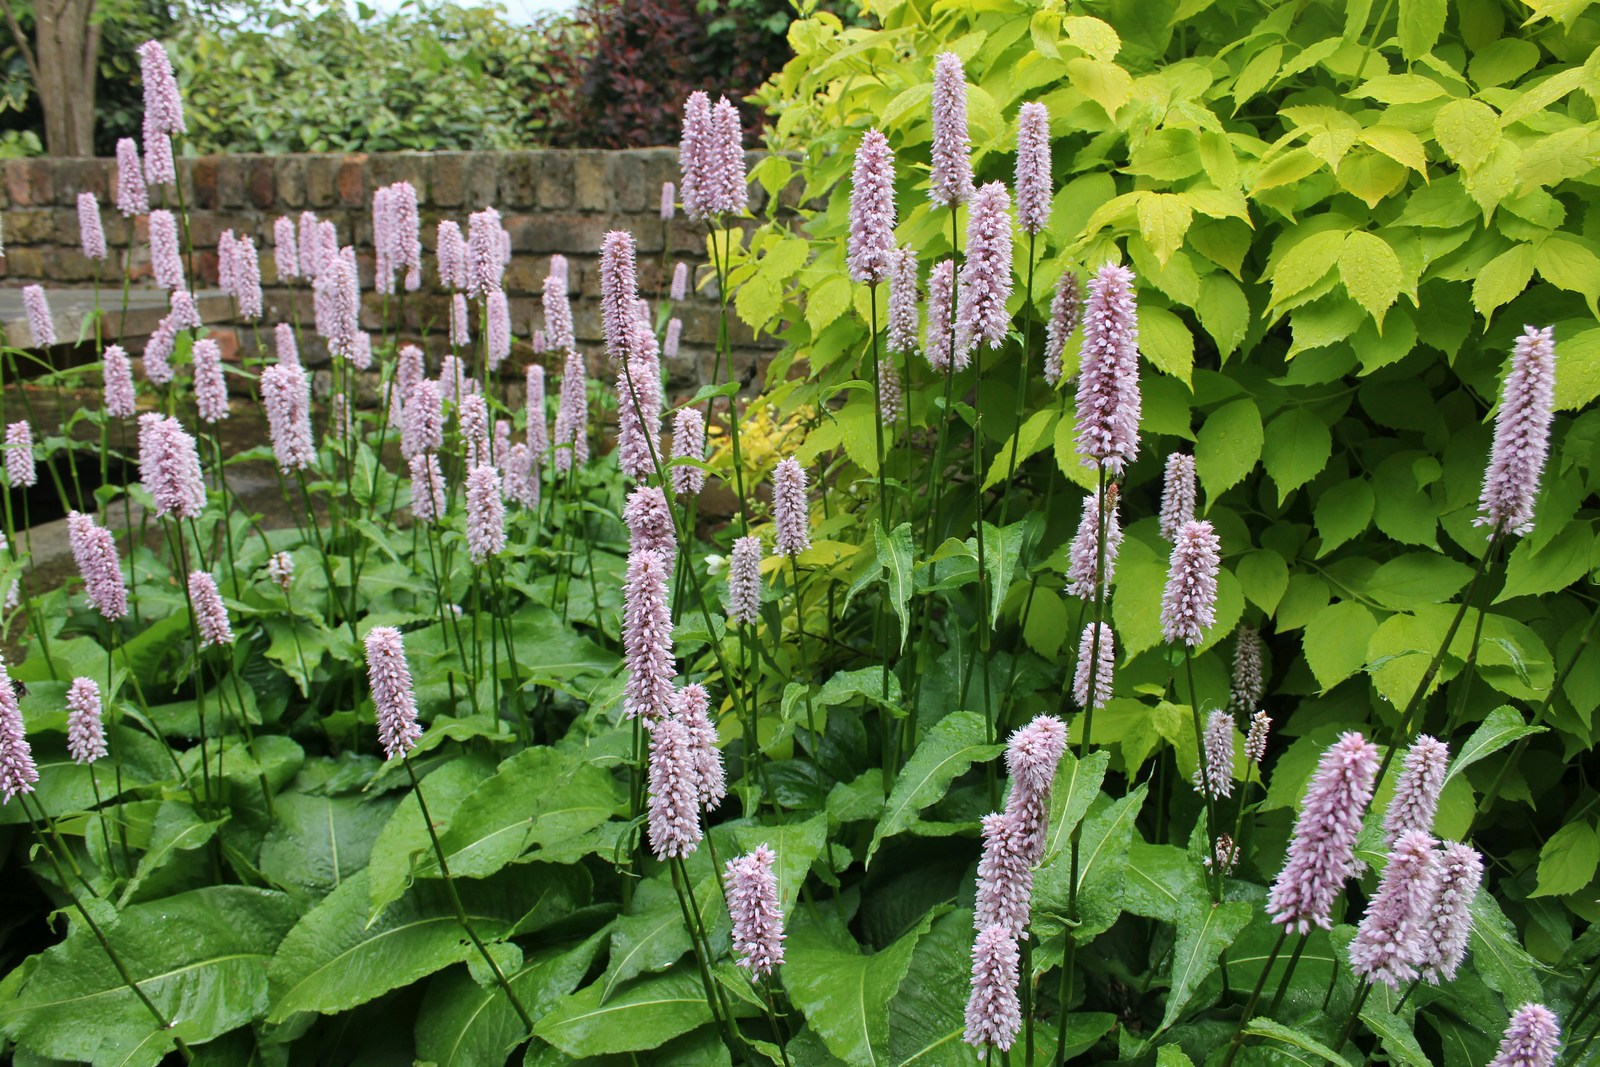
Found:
[1267,731,1378,934]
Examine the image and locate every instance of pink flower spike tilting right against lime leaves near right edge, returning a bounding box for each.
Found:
[1477,326,1555,534]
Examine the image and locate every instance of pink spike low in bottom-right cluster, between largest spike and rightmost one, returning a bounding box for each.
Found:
[1350,830,1438,989]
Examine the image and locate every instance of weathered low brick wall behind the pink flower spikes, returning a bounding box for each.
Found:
[0,149,763,387]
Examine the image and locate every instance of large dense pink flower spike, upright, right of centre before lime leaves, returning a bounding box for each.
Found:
[1078,262,1139,477]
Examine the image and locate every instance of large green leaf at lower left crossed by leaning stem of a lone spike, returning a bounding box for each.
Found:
[267,865,587,1022]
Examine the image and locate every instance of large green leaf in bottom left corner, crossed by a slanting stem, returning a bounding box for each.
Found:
[0,886,294,1067]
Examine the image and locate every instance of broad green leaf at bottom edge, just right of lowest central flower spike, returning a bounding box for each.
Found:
[782,912,934,1067]
